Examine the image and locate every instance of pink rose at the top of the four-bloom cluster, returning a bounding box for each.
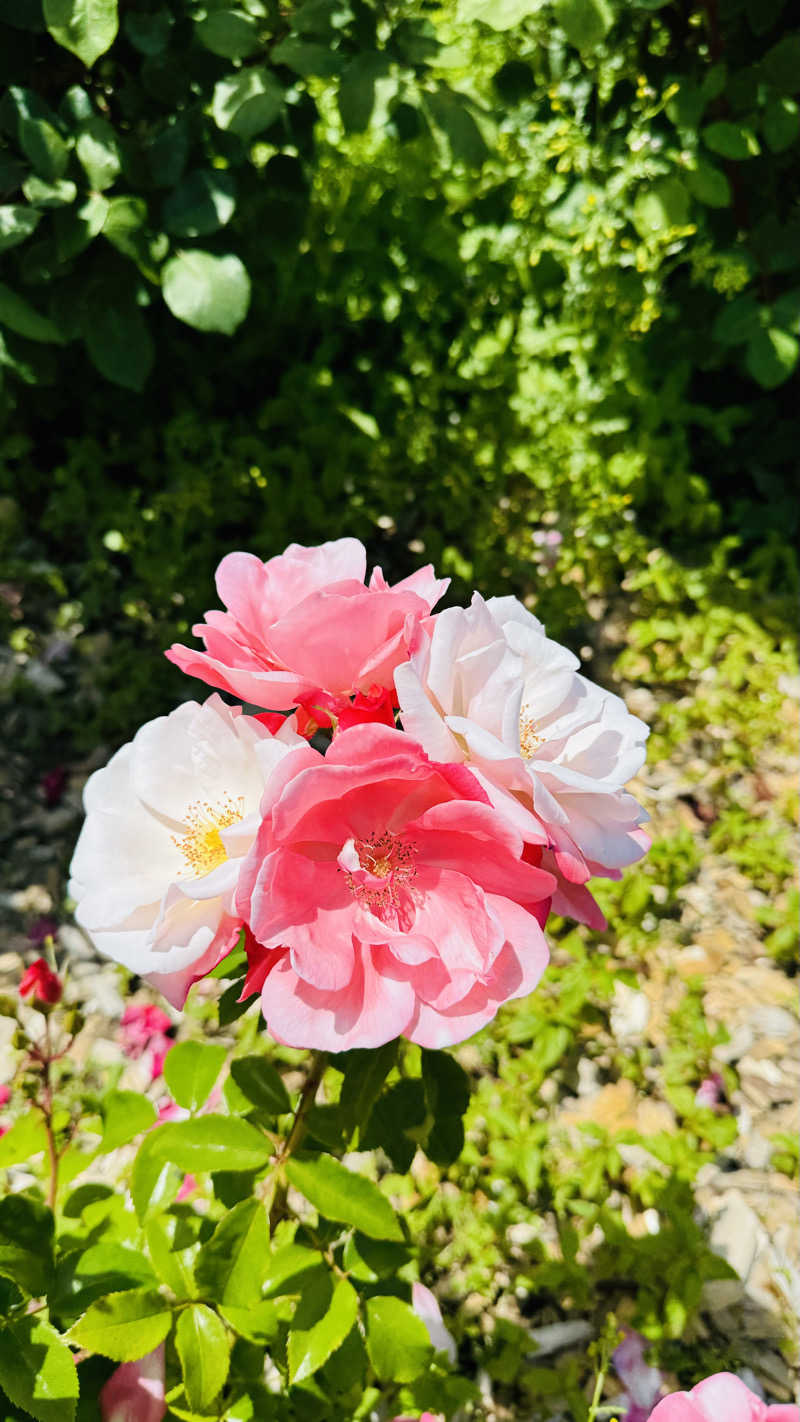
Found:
[166,538,448,725]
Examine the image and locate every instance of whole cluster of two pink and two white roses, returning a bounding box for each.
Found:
[70,538,648,1051]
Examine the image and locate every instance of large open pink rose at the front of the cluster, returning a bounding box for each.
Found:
[236,725,553,1052]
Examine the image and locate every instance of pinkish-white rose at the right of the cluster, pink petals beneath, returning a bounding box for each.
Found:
[395,593,649,929]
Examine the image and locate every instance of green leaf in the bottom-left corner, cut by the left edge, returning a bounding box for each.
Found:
[0,1314,78,1422]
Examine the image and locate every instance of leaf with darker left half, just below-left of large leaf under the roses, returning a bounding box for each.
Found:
[195,1200,270,1308]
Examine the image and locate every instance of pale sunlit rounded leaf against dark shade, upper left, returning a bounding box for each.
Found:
[162,250,250,334]
